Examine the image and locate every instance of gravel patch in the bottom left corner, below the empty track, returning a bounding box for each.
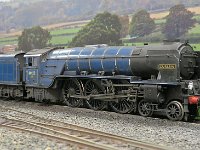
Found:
[0,128,71,150]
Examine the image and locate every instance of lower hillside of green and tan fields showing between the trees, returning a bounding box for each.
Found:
[0,6,200,50]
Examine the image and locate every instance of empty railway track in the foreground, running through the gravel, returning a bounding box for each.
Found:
[0,107,168,150]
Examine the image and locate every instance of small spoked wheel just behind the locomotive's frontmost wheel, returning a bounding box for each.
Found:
[138,100,153,117]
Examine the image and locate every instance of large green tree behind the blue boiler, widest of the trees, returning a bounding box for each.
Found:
[69,12,121,47]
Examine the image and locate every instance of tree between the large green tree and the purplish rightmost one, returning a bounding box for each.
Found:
[129,10,156,37]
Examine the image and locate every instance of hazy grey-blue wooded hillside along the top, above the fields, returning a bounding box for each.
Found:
[0,0,200,31]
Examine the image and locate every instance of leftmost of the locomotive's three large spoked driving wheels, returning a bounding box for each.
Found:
[62,79,83,107]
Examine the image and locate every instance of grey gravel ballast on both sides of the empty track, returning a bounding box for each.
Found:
[0,101,200,150]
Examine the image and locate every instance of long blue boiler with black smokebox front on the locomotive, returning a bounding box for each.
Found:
[49,42,196,79]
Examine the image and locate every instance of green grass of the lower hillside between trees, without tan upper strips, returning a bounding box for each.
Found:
[0,15,200,46]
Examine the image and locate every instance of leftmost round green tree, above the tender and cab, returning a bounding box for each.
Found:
[18,26,51,52]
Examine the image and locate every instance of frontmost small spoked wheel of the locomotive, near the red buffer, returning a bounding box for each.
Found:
[166,101,184,121]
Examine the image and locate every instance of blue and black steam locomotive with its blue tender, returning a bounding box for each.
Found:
[0,42,200,121]
